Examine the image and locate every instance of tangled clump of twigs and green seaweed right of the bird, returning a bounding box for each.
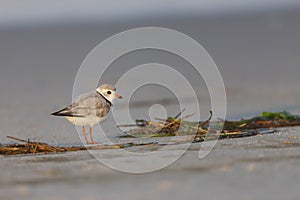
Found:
[119,110,300,142]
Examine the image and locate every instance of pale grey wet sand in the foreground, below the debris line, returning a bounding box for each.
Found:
[0,127,300,199]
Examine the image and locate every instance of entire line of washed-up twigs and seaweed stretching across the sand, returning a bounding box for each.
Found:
[0,110,300,155]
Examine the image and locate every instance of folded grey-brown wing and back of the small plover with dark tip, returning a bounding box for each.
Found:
[53,92,110,117]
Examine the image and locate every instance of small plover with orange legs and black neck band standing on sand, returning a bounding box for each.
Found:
[51,84,122,144]
